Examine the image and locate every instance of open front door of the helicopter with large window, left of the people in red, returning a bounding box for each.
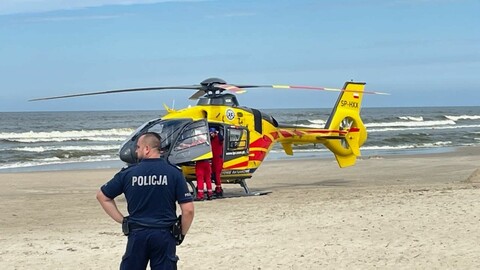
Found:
[168,119,212,165]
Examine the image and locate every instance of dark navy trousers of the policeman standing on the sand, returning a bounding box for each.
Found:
[120,228,178,270]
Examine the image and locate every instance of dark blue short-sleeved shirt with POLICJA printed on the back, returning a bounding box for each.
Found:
[101,158,193,228]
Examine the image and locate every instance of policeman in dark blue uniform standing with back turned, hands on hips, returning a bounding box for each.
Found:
[97,132,194,269]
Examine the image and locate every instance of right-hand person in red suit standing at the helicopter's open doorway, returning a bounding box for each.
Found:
[210,128,223,197]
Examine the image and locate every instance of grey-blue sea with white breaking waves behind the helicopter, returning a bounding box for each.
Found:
[0,106,480,173]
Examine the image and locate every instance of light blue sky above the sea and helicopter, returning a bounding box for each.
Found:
[0,0,480,111]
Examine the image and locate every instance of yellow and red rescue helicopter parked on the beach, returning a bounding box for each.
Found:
[30,78,386,197]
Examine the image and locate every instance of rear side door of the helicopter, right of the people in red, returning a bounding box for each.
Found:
[224,127,249,169]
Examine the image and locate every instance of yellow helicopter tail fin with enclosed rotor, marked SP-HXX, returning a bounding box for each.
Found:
[325,82,367,168]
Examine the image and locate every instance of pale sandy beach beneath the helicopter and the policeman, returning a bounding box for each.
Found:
[0,148,480,270]
